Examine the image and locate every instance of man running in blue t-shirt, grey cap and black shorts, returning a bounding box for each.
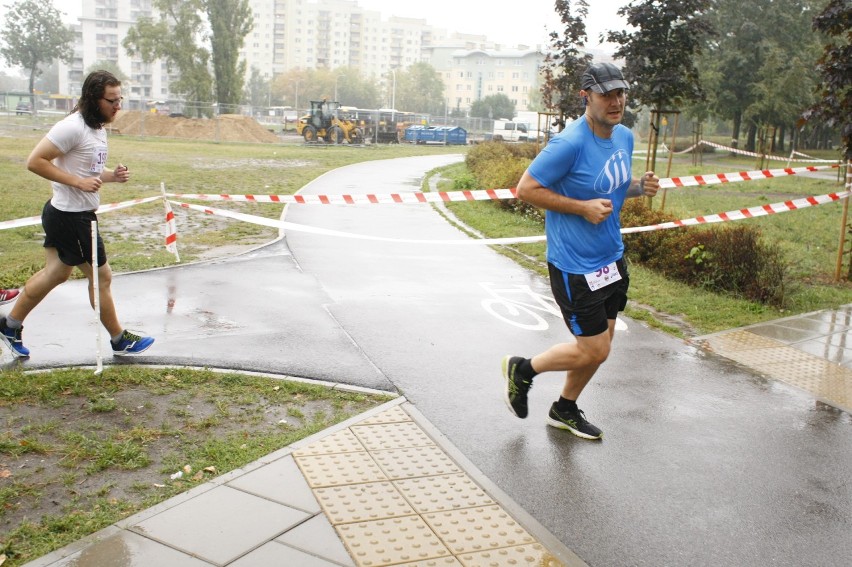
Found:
[502,63,660,439]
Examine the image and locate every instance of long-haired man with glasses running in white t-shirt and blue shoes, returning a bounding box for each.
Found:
[0,71,154,357]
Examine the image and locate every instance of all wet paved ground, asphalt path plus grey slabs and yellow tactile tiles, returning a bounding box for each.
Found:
[8,158,852,567]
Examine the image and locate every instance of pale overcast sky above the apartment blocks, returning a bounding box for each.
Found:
[45,0,632,48]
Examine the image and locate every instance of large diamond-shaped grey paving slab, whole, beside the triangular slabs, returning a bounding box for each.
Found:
[130,486,310,565]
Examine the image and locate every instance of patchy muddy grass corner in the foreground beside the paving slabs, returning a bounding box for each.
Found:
[0,366,391,567]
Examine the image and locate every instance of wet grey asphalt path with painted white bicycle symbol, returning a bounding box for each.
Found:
[3,156,852,566]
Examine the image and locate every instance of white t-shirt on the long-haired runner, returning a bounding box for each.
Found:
[47,112,107,212]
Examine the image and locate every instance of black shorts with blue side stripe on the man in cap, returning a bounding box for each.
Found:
[547,258,630,337]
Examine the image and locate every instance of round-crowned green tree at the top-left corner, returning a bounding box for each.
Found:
[0,0,74,93]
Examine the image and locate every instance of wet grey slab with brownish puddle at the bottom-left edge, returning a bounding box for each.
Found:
[39,531,212,567]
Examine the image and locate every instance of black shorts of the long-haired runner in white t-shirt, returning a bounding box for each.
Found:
[41,201,107,267]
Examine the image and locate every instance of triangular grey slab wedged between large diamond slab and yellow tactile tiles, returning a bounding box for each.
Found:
[227,456,320,514]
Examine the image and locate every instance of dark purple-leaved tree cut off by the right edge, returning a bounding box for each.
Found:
[803,0,852,161]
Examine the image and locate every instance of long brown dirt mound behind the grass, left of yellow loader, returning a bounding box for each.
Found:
[112,110,279,143]
